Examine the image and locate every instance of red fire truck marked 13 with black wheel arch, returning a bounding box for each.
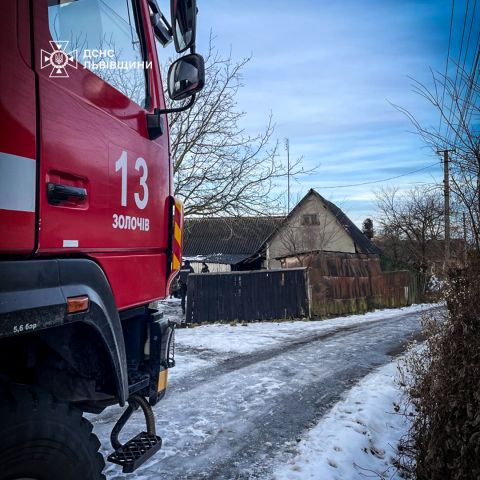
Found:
[0,0,204,480]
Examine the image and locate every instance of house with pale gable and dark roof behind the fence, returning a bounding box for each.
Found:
[184,189,380,271]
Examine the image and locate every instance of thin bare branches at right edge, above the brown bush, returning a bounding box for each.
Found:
[395,61,480,253]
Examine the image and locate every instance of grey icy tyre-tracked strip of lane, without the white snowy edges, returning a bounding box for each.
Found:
[100,313,438,480]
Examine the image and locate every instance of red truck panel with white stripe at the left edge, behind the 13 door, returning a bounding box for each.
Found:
[0,1,36,254]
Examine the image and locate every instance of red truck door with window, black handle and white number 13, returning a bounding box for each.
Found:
[32,0,170,308]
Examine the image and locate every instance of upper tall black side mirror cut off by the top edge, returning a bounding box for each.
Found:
[170,0,197,53]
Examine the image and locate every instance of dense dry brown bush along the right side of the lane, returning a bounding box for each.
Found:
[400,264,480,480]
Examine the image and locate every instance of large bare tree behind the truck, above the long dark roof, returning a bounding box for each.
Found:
[167,36,306,216]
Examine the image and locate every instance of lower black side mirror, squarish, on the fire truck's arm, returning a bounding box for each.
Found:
[168,53,205,100]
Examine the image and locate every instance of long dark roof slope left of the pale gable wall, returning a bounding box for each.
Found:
[183,216,285,258]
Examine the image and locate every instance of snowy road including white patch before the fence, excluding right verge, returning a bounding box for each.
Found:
[94,303,438,480]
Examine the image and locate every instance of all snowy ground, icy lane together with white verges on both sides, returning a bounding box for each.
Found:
[89,300,430,480]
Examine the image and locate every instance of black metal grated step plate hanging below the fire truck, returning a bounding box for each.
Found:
[108,432,162,473]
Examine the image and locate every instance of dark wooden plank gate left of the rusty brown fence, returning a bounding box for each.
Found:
[186,268,309,323]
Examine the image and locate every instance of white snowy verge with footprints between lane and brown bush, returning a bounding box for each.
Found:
[273,361,408,480]
